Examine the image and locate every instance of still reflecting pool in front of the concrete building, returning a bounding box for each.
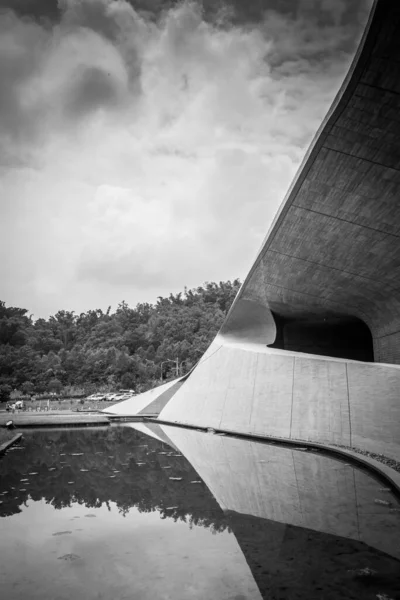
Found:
[0,423,400,600]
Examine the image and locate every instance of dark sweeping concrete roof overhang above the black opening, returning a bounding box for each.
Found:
[221,0,400,362]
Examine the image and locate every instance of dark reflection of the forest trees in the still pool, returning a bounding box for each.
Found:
[0,427,229,532]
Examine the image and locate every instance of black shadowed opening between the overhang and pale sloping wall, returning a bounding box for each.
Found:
[269,313,374,362]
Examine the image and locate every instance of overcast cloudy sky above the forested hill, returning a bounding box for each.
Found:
[0,0,371,318]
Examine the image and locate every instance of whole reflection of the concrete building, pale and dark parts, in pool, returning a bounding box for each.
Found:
[132,424,400,599]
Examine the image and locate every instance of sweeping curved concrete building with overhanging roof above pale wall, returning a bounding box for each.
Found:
[108,0,400,458]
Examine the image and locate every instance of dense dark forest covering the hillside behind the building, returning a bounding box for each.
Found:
[0,279,240,400]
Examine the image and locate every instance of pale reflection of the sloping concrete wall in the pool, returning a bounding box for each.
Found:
[162,425,400,558]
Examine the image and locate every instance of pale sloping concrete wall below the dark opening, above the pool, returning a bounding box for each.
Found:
[160,336,400,460]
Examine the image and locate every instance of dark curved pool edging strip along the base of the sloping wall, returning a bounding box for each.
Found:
[148,417,400,498]
